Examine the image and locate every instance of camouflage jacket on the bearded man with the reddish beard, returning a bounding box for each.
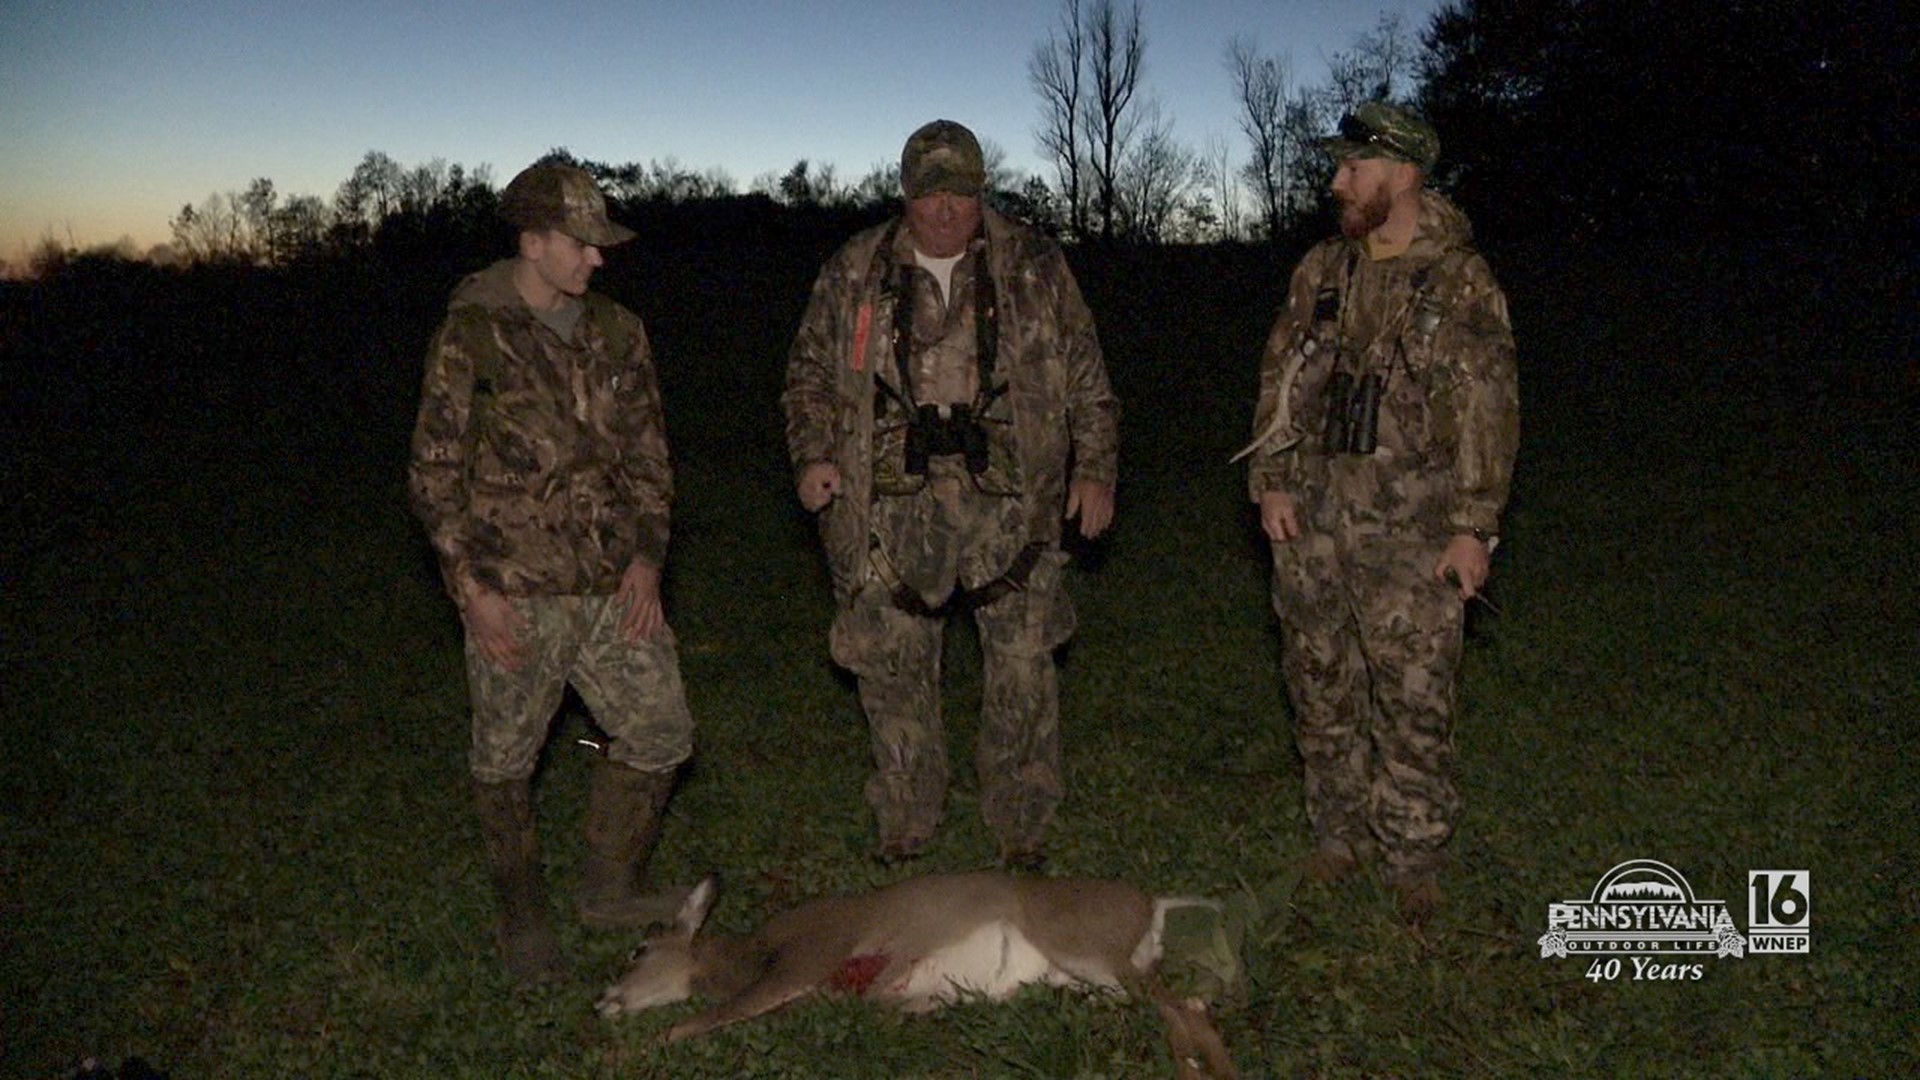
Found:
[1248,192,1519,532]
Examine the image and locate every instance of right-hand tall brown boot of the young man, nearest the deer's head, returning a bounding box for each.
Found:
[578,759,685,930]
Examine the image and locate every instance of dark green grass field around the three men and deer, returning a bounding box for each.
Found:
[0,231,1920,1080]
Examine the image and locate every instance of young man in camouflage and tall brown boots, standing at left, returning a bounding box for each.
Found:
[409,165,693,980]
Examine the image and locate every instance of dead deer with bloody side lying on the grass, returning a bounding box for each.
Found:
[595,872,1235,1078]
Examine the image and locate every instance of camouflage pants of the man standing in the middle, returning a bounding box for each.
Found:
[829,463,1073,849]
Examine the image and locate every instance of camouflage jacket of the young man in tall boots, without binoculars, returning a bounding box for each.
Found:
[409,259,674,600]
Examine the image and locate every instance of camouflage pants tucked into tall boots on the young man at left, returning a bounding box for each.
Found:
[467,596,693,782]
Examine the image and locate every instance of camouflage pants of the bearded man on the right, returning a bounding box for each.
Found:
[1273,530,1463,874]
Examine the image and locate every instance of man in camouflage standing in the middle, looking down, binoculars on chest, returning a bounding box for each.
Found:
[783,121,1119,865]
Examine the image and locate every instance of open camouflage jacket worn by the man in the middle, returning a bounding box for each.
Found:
[781,209,1119,596]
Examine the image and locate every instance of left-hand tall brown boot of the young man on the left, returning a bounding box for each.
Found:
[474,780,566,984]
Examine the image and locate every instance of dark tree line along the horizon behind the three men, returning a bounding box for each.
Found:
[11,0,1889,282]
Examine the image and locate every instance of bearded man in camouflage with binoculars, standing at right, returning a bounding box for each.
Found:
[1248,102,1519,922]
